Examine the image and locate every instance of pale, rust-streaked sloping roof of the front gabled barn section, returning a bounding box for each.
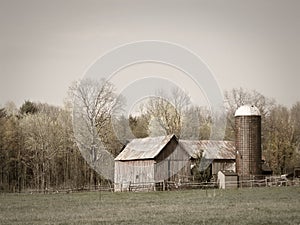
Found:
[115,135,176,161]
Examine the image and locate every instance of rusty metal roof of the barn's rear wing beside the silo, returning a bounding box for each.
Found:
[179,140,235,159]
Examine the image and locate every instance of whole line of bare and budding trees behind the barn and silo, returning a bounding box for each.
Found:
[0,80,300,192]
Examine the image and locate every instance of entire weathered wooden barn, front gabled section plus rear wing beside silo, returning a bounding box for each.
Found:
[114,135,235,191]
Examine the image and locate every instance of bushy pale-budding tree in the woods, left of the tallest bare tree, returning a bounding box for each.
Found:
[20,104,66,190]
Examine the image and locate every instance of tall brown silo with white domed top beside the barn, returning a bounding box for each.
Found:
[234,105,261,180]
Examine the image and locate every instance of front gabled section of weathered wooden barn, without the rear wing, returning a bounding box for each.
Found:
[114,135,191,191]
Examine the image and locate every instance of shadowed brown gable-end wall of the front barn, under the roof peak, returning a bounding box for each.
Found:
[154,140,191,182]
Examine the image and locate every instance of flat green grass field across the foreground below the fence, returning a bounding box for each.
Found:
[0,187,300,225]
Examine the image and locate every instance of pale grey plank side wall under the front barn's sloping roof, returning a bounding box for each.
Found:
[115,160,154,191]
